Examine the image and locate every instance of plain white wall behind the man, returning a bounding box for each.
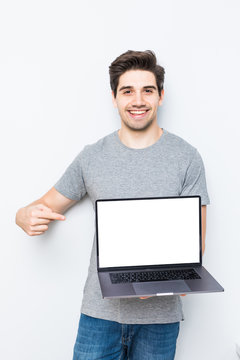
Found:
[0,0,240,360]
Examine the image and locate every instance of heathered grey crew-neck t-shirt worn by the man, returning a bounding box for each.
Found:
[55,129,209,324]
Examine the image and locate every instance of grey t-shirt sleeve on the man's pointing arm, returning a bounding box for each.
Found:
[54,148,87,200]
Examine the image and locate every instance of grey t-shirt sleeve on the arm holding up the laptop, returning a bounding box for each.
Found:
[180,150,210,205]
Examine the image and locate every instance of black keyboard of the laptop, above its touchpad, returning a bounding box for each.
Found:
[109,269,201,284]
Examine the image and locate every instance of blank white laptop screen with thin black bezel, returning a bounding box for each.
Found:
[96,196,201,268]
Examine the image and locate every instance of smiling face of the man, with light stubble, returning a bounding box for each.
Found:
[112,70,163,131]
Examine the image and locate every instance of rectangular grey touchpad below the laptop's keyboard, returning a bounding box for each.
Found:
[132,280,190,295]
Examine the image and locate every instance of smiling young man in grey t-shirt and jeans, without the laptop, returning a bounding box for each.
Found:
[16,51,209,360]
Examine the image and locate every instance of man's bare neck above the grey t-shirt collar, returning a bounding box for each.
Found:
[118,125,163,149]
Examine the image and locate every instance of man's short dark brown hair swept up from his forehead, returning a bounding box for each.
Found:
[109,50,165,97]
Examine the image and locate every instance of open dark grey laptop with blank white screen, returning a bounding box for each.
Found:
[95,196,224,299]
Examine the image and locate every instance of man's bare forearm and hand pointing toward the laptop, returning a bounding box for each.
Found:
[16,187,77,236]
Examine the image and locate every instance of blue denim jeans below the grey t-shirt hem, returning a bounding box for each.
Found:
[73,314,179,360]
